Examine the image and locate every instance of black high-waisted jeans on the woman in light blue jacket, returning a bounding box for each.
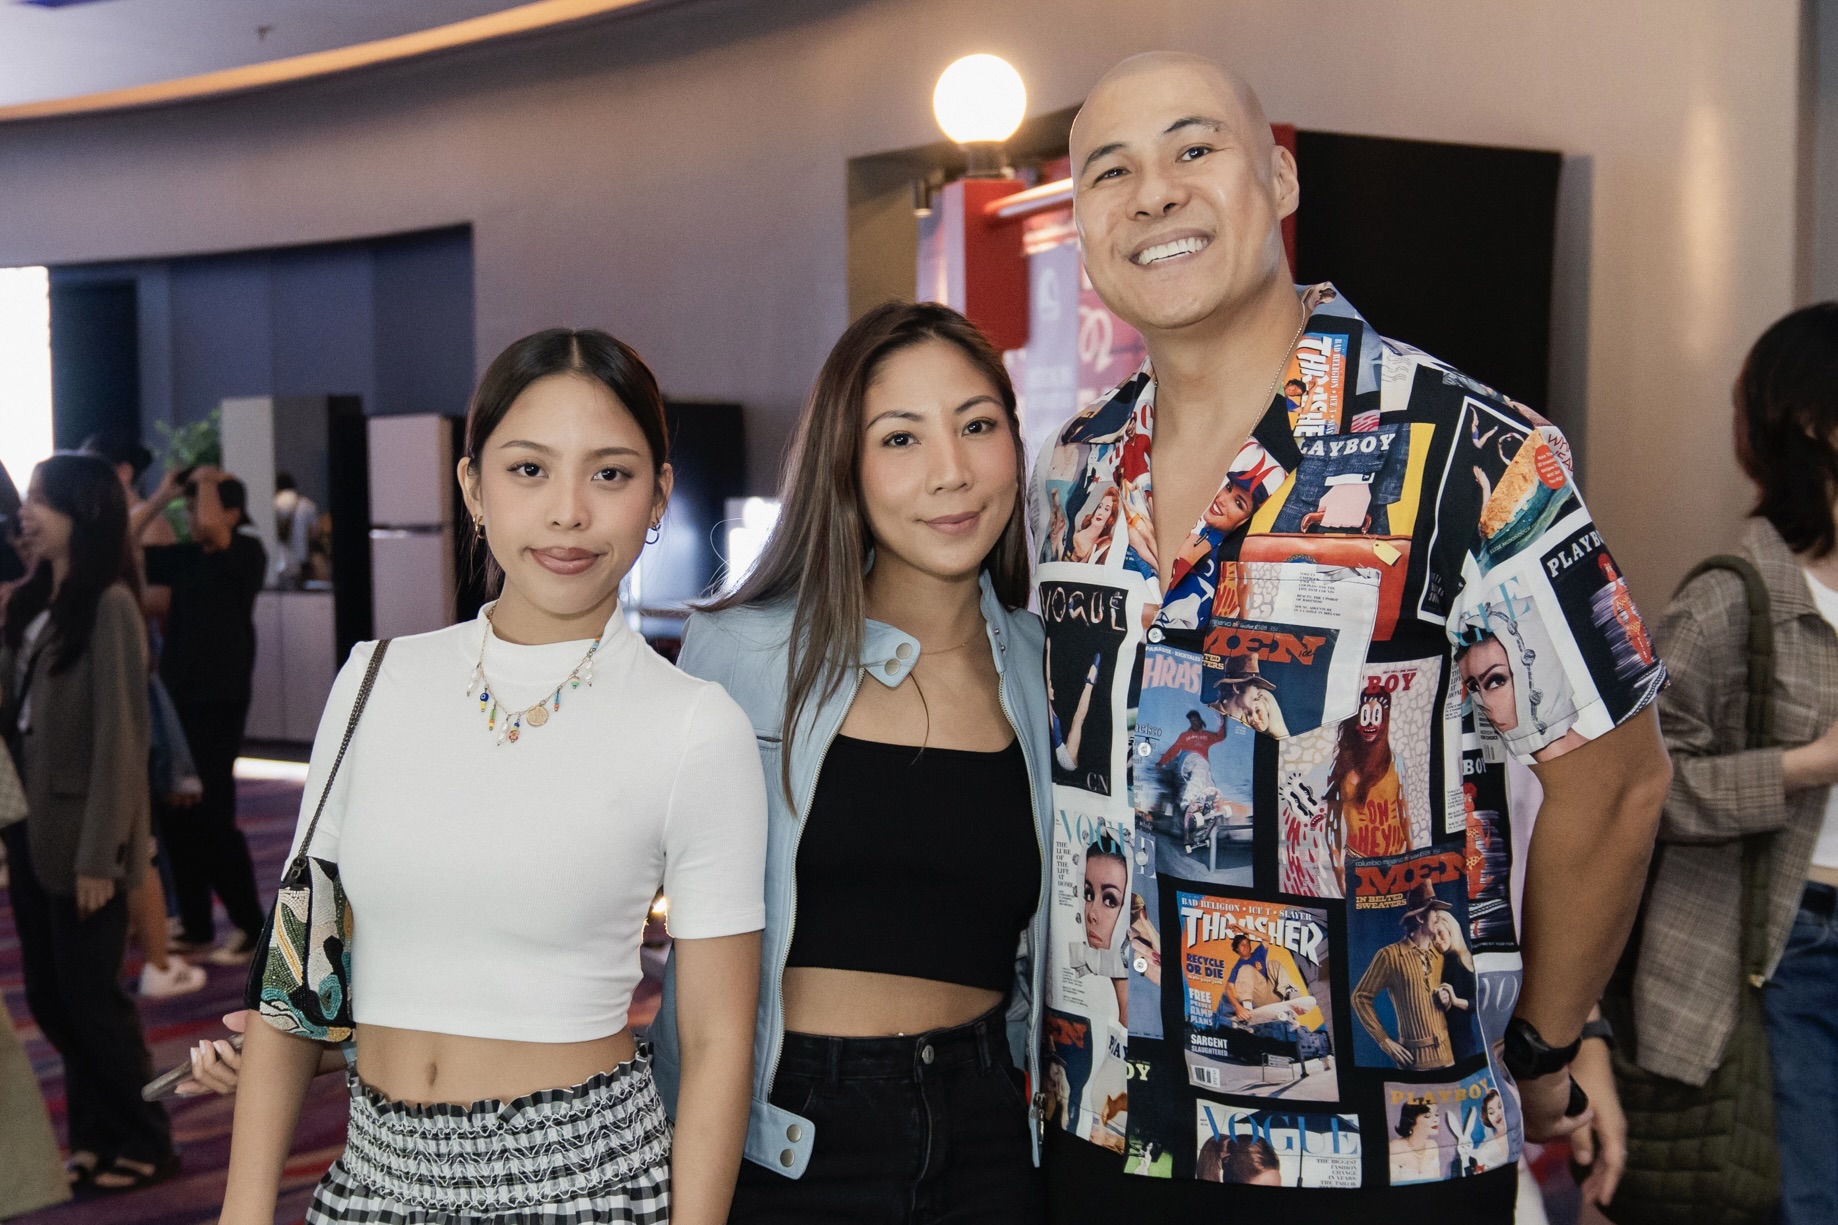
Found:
[728,1008,1046,1225]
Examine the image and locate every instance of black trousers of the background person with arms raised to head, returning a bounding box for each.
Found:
[160,703,265,944]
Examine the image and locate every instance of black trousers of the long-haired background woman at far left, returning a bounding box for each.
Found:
[0,824,173,1164]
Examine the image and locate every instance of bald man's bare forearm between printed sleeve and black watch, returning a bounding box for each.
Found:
[1516,714,1671,1047]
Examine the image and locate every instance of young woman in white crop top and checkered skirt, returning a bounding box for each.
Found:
[222,329,765,1225]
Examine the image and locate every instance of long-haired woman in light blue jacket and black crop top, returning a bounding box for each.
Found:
[651,303,1051,1225]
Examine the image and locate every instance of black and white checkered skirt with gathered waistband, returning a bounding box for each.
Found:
[307,1050,671,1225]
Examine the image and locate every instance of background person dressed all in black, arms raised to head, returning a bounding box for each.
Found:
[134,465,268,966]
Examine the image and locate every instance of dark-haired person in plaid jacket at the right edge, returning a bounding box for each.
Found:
[1634,302,1838,1225]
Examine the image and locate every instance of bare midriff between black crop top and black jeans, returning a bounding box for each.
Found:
[785,966,1002,1037]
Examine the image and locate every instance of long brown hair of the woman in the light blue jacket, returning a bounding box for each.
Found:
[702,302,1027,798]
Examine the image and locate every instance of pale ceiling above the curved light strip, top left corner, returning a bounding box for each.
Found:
[0,0,588,107]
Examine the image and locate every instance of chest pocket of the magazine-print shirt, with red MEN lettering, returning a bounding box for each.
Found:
[1204,561,1380,739]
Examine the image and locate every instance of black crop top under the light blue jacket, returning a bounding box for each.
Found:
[785,736,1040,993]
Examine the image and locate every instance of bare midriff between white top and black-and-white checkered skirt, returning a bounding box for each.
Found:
[357,1025,638,1105]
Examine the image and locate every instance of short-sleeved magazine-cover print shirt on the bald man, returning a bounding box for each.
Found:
[1033,285,1665,1188]
